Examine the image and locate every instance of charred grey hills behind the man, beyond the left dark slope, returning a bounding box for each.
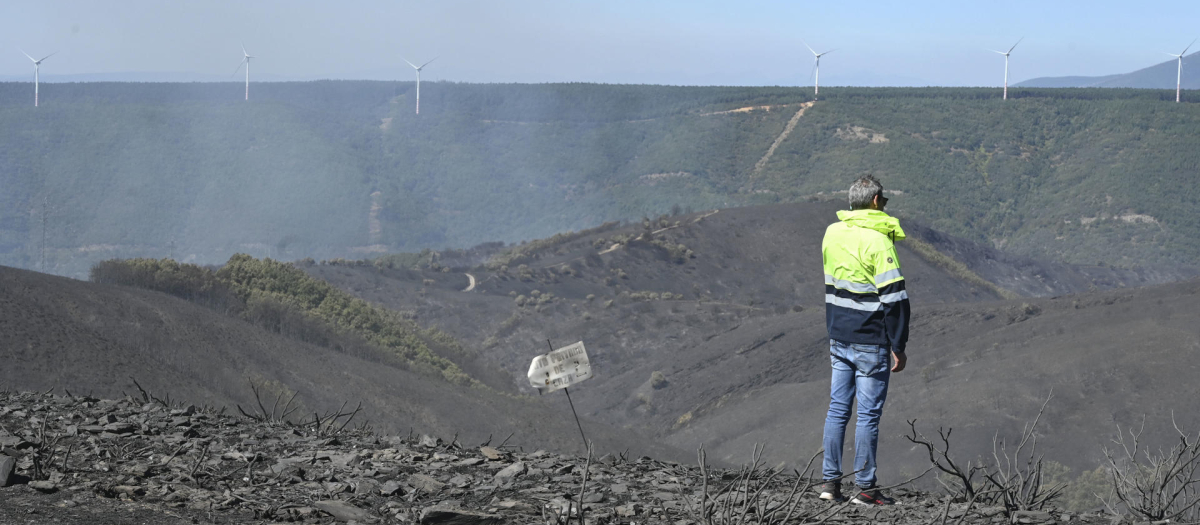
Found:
[307,203,1200,479]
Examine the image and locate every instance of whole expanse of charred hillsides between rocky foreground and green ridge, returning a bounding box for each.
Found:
[0,198,1200,505]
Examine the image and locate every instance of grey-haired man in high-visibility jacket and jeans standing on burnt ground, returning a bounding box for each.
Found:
[821,175,908,505]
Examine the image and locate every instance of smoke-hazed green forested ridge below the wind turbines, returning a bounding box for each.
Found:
[0,82,1200,277]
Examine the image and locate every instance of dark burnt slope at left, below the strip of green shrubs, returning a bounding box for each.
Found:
[0,267,680,458]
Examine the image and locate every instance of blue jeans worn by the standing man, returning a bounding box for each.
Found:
[822,339,892,489]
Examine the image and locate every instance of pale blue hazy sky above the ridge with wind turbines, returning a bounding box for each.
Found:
[0,0,1200,85]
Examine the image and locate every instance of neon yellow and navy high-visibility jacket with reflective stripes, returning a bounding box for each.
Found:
[821,210,908,352]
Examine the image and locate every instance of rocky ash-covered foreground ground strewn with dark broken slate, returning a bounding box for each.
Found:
[0,392,1111,525]
